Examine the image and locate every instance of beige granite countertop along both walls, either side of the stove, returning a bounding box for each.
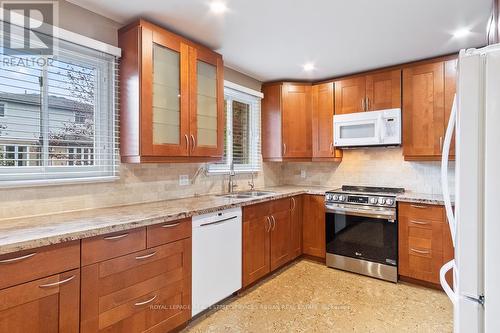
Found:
[0,186,443,255]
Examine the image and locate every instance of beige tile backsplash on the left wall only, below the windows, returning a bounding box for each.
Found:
[0,163,281,219]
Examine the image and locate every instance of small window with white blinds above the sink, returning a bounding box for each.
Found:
[208,87,262,173]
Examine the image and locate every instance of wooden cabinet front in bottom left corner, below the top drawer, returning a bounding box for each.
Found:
[0,269,80,333]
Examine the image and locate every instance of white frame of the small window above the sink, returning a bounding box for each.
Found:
[207,81,262,174]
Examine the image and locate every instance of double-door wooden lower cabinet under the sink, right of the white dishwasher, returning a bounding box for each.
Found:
[243,196,302,287]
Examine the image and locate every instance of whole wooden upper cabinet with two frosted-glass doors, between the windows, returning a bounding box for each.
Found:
[119,20,224,162]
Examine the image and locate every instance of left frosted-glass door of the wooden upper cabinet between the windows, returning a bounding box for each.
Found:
[140,29,190,156]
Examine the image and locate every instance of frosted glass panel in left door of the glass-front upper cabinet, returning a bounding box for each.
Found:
[153,44,180,144]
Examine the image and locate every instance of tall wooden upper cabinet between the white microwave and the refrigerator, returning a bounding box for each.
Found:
[403,61,445,160]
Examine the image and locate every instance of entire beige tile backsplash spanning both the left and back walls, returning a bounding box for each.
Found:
[0,148,453,218]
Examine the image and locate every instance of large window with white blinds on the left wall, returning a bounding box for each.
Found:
[0,22,119,186]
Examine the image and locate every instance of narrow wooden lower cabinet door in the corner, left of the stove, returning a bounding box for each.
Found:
[302,195,326,258]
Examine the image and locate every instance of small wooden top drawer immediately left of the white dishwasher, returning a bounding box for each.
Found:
[146,218,192,248]
